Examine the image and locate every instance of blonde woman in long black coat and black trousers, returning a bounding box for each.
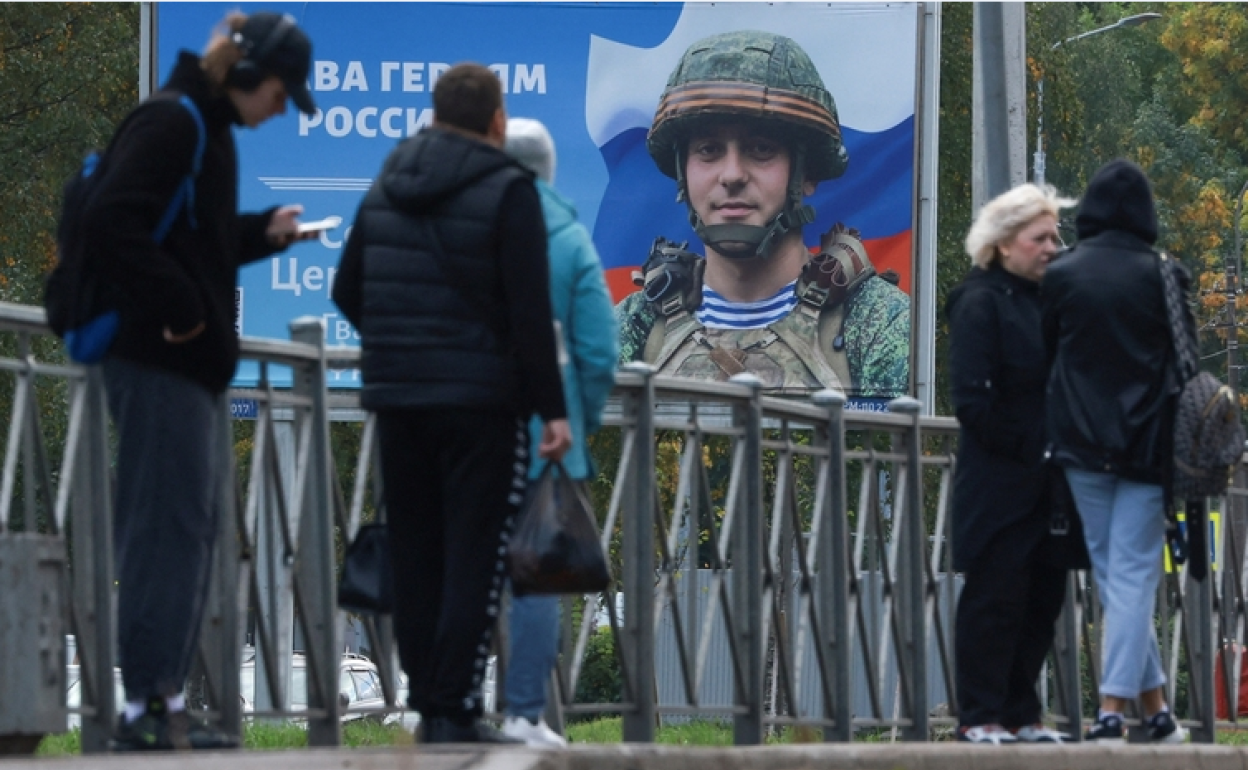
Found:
[946,185,1073,744]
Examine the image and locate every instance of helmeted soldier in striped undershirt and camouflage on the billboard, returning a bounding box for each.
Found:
[615,31,910,398]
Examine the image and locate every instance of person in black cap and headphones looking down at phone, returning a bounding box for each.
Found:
[81,12,316,751]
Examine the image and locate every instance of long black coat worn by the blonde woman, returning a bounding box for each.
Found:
[946,263,1050,570]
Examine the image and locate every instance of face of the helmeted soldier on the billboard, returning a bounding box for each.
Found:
[685,122,814,227]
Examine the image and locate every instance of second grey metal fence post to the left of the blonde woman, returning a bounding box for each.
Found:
[814,391,861,743]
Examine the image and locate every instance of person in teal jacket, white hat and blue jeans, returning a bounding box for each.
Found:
[503,117,619,748]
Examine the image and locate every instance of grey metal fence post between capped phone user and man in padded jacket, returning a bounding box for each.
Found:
[291,316,342,746]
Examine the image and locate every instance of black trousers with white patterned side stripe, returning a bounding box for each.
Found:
[377,407,528,721]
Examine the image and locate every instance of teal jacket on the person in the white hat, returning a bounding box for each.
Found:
[529,180,619,478]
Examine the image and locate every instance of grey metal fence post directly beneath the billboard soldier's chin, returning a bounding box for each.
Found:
[729,374,766,746]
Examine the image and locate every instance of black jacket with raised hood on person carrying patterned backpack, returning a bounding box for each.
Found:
[1041,160,1188,484]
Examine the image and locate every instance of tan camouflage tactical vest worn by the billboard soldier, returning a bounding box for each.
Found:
[634,225,875,394]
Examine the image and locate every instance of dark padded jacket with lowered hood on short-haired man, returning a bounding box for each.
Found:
[333,129,565,421]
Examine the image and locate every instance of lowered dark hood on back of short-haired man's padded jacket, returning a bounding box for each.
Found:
[378,127,521,213]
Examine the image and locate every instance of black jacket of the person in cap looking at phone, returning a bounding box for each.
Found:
[82,51,278,393]
